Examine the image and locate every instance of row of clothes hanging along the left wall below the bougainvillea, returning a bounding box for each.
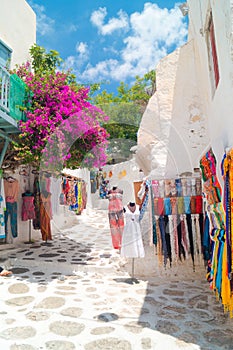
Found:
[0,166,87,243]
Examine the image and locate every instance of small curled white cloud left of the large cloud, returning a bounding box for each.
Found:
[91,7,128,35]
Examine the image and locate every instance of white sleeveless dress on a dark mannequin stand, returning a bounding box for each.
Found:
[120,202,145,258]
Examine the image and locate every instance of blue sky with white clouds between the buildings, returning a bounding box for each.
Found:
[28,0,187,91]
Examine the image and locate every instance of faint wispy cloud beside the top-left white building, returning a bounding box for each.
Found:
[29,0,55,36]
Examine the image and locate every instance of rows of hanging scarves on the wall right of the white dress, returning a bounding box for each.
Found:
[151,176,204,271]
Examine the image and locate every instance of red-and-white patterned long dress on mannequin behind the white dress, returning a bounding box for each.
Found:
[108,186,124,249]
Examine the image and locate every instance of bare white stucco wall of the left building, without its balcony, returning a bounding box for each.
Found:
[0,0,37,249]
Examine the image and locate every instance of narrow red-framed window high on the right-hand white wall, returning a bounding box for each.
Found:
[207,13,220,91]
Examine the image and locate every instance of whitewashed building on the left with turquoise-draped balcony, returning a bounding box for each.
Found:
[0,0,38,245]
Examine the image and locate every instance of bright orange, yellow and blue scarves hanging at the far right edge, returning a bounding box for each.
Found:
[200,149,233,317]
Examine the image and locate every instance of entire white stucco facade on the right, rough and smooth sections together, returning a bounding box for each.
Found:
[136,0,233,186]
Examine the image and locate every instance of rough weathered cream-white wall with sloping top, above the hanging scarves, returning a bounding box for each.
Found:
[136,41,209,179]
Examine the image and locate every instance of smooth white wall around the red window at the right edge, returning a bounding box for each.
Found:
[188,0,233,186]
